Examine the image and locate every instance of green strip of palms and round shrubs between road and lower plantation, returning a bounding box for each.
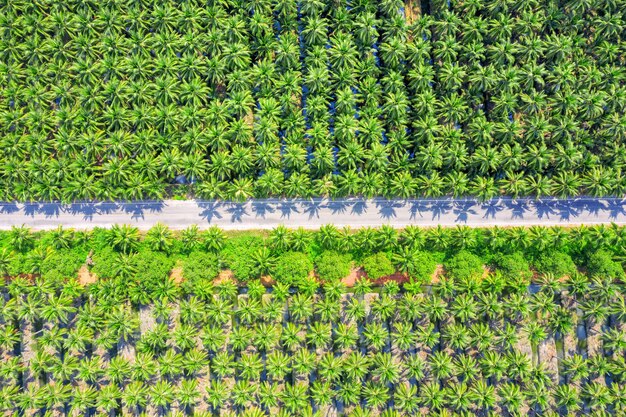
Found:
[0,224,626,286]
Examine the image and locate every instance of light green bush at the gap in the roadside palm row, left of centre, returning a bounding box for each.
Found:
[222,235,263,282]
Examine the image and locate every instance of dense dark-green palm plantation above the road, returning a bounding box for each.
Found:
[0,0,626,201]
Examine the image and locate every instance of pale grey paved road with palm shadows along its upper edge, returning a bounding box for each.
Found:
[0,198,626,230]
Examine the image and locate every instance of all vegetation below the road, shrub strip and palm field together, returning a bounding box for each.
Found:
[0,226,626,417]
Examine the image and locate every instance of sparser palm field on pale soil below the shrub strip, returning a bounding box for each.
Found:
[0,275,626,417]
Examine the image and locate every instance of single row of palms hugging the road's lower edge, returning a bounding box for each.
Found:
[0,223,626,254]
